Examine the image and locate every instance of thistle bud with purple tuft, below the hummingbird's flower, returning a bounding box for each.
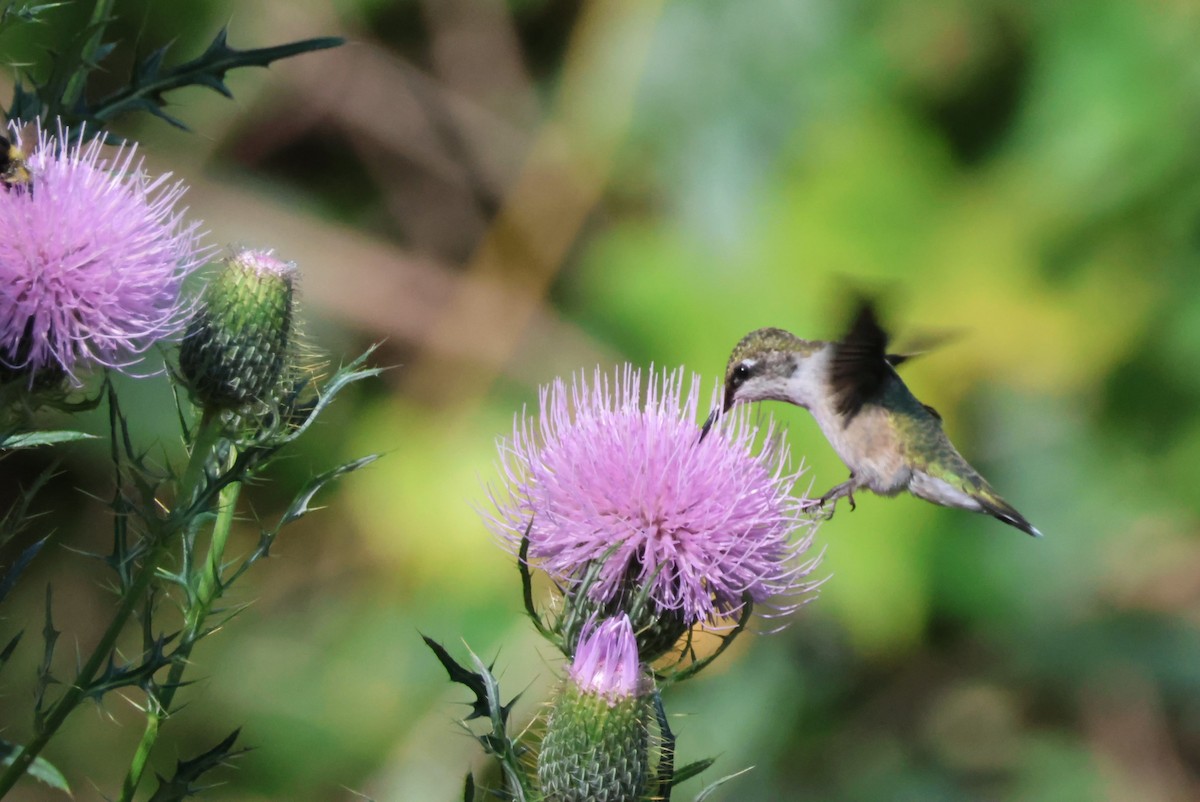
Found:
[538,615,652,802]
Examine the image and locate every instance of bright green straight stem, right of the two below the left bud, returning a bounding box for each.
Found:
[120,481,241,802]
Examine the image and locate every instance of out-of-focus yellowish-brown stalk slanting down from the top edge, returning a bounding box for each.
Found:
[404,0,660,401]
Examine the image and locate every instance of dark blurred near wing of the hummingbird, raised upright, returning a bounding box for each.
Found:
[829,300,904,424]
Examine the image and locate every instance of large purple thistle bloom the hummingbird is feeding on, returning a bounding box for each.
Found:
[487,365,820,640]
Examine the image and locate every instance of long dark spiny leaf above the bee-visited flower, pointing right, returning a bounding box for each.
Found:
[86,28,344,131]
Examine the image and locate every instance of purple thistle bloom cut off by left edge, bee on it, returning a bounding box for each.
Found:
[0,126,208,382]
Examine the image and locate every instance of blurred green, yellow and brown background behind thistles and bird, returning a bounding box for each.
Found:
[0,0,1200,802]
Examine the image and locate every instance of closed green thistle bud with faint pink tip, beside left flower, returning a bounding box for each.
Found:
[179,251,295,411]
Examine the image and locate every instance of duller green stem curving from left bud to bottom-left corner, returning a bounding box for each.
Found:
[0,410,222,797]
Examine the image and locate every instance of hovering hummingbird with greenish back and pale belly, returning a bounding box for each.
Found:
[701,299,1042,538]
